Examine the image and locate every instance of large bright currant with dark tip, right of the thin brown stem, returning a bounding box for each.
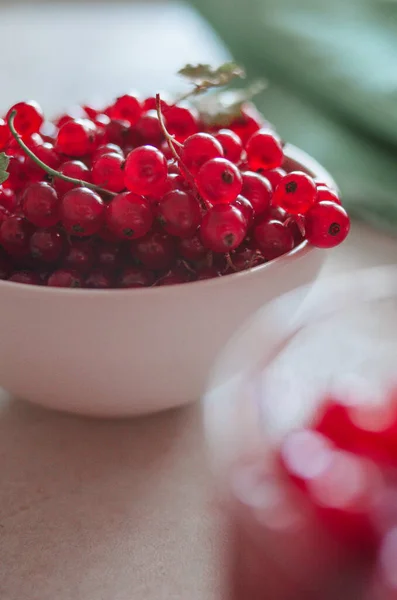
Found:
[196,158,243,204]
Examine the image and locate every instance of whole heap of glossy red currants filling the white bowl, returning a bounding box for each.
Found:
[0,94,349,288]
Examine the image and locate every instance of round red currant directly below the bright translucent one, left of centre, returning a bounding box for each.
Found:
[106,192,154,240]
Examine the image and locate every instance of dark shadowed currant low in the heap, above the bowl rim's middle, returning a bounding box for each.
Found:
[131,231,176,271]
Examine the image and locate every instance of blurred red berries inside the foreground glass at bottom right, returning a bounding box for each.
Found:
[279,390,397,600]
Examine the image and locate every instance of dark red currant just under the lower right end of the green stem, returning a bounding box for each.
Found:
[60,187,106,237]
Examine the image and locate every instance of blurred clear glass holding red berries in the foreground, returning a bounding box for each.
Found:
[204,268,397,600]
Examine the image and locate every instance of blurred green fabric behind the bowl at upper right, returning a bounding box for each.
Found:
[188,0,397,232]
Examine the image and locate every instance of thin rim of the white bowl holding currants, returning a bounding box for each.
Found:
[0,144,338,298]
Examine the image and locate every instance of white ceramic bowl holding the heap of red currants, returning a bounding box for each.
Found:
[0,147,334,417]
